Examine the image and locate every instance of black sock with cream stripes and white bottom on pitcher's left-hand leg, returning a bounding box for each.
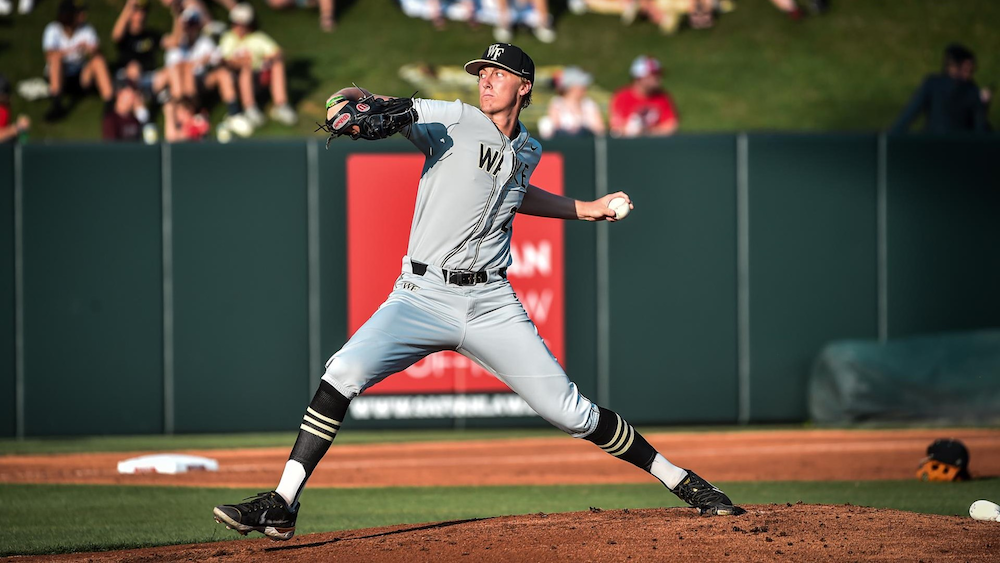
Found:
[276,381,351,506]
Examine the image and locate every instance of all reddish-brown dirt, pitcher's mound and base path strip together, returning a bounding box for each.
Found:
[0,429,1000,563]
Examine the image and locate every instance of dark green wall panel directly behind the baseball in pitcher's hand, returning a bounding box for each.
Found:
[607,135,738,423]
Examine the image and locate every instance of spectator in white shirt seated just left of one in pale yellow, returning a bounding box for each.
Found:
[163,7,253,137]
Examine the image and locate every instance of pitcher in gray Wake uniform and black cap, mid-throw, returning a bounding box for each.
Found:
[214,43,743,540]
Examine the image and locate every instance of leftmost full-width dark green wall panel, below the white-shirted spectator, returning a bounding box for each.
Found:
[23,144,163,435]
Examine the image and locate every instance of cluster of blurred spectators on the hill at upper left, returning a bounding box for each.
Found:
[0,0,302,142]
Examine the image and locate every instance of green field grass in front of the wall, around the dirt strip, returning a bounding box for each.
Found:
[0,427,1000,556]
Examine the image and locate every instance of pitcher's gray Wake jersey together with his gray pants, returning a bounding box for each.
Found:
[323,99,598,436]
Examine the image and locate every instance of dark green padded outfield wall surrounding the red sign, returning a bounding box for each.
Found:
[0,134,1000,436]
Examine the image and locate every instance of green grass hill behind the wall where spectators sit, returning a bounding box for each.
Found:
[0,0,1000,139]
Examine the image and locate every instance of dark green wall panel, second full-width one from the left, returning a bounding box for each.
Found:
[170,143,309,432]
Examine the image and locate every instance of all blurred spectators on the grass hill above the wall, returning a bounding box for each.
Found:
[0,0,992,143]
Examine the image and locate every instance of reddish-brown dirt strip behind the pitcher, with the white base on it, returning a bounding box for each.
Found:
[0,429,1000,489]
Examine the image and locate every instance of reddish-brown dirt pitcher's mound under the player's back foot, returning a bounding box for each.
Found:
[18,504,1000,563]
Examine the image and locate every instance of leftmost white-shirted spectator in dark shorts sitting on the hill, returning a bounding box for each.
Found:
[42,0,114,121]
